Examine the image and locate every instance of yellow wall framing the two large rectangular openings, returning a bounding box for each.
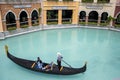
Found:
[43,1,79,25]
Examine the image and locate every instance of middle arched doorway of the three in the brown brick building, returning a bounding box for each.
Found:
[20,11,28,28]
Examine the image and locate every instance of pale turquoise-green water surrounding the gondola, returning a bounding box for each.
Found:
[0,28,120,80]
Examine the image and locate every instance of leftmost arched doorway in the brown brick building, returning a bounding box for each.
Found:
[6,12,16,30]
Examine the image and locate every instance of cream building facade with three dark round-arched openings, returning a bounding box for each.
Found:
[79,0,116,25]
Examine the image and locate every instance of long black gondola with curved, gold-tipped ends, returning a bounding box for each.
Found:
[5,45,87,75]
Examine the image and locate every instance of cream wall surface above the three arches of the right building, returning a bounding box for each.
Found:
[79,0,116,17]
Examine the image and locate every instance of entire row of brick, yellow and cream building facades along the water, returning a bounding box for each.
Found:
[0,0,120,32]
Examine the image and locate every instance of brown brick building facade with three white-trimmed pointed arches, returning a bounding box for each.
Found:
[0,0,41,32]
